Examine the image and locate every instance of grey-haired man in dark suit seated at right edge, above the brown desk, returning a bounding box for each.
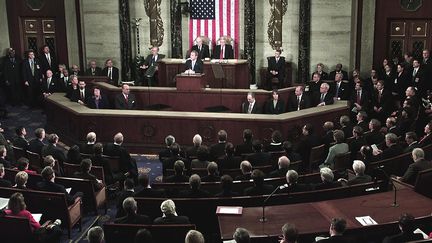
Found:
[396,148,432,185]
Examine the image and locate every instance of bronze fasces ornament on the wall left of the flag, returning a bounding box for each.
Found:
[144,0,164,46]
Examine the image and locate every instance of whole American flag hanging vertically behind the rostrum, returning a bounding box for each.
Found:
[189,0,240,58]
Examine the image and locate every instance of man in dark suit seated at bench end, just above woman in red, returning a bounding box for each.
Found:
[36,166,82,205]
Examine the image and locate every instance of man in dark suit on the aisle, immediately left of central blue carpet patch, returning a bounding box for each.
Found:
[104,133,138,180]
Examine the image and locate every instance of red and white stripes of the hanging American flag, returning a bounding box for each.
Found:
[189,0,240,58]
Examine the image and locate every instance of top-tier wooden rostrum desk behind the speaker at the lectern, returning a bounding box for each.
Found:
[158,58,249,89]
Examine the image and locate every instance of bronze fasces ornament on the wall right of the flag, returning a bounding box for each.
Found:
[267,0,288,50]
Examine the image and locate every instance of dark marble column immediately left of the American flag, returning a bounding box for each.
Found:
[170,1,182,58]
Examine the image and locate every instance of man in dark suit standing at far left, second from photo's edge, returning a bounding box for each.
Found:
[22,50,42,106]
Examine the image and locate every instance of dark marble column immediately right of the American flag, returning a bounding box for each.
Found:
[244,0,255,84]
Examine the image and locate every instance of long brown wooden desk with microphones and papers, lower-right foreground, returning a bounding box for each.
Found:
[218,188,432,242]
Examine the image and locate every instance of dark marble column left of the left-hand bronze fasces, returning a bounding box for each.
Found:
[119,0,132,81]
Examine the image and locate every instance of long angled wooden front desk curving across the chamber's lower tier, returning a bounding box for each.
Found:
[45,93,349,153]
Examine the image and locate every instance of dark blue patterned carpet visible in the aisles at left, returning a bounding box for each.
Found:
[0,106,162,242]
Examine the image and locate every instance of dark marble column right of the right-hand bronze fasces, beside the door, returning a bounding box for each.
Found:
[298,0,311,83]
